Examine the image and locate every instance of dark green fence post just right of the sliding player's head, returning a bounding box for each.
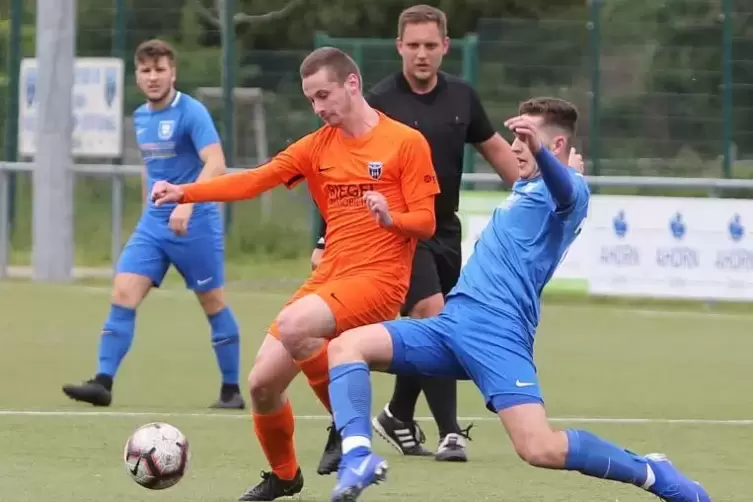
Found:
[586,0,601,180]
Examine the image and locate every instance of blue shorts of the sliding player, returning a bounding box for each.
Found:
[383,301,544,413]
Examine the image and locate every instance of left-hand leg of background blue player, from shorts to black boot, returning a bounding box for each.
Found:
[63,226,168,406]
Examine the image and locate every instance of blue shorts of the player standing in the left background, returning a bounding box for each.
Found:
[117,211,225,293]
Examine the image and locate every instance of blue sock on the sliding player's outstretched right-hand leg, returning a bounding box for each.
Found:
[565,429,648,486]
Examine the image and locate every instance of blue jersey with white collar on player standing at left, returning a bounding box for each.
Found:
[133,92,220,219]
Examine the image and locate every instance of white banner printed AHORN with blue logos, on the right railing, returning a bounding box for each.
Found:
[586,196,753,300]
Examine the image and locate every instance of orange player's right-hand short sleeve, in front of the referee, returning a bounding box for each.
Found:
[401,130,439,210]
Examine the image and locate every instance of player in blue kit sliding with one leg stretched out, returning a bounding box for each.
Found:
[329,98,711,502]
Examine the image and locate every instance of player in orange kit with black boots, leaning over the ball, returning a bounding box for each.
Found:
[152,47,439,501]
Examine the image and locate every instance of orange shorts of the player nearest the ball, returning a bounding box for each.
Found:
[268,274,405,339]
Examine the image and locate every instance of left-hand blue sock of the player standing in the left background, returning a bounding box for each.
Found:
[97,305,136,378]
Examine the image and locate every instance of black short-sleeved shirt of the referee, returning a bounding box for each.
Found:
[319,72,496,243]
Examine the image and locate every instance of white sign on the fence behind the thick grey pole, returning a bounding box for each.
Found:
[18,58,123,158]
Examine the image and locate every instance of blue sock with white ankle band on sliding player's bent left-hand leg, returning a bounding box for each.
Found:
[329,362,371,455]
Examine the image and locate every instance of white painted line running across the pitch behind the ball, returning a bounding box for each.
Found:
[0,410,753,426]
